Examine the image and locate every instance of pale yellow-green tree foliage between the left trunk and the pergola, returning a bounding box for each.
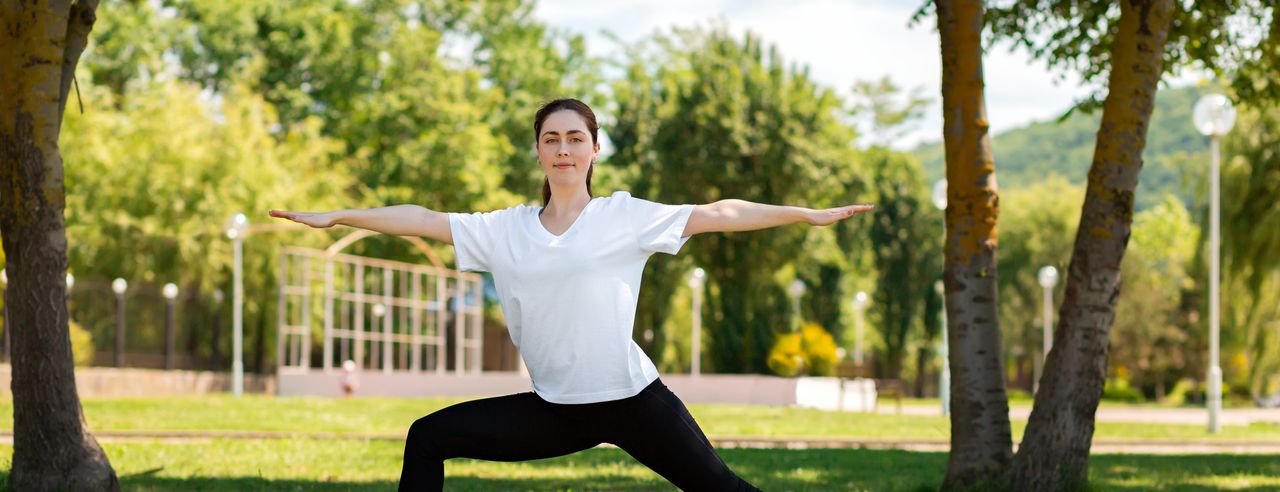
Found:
[61,77,351,363]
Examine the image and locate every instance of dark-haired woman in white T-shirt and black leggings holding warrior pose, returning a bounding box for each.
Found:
[270,99,872,491]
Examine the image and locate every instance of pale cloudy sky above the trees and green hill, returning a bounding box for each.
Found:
[534,0,1198,149]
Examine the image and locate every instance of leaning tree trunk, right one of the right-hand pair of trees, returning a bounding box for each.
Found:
[1009,0,1174,491]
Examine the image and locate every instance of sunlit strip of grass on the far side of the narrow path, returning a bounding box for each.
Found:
[0,395,1280,442]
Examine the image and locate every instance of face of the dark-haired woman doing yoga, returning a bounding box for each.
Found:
[538,109,600,192]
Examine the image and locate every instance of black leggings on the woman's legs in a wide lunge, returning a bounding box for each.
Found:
[399,379,756,491]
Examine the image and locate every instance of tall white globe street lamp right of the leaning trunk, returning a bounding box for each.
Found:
[1192,94,1235,433]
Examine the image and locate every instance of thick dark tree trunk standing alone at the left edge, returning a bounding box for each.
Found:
[0,0,119,491]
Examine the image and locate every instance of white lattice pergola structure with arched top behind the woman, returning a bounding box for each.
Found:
[276,231,484,376]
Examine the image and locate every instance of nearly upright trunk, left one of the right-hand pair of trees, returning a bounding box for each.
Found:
[936,0,1012,488]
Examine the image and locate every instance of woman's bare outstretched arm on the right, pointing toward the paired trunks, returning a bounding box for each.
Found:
[684,200,873,236]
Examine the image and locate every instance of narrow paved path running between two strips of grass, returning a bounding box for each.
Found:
[0,431,1280,455]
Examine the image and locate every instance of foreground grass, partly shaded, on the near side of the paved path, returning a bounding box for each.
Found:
[0,439,1280,491]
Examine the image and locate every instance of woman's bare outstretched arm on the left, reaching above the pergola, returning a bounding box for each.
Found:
[269,205,453,245]
